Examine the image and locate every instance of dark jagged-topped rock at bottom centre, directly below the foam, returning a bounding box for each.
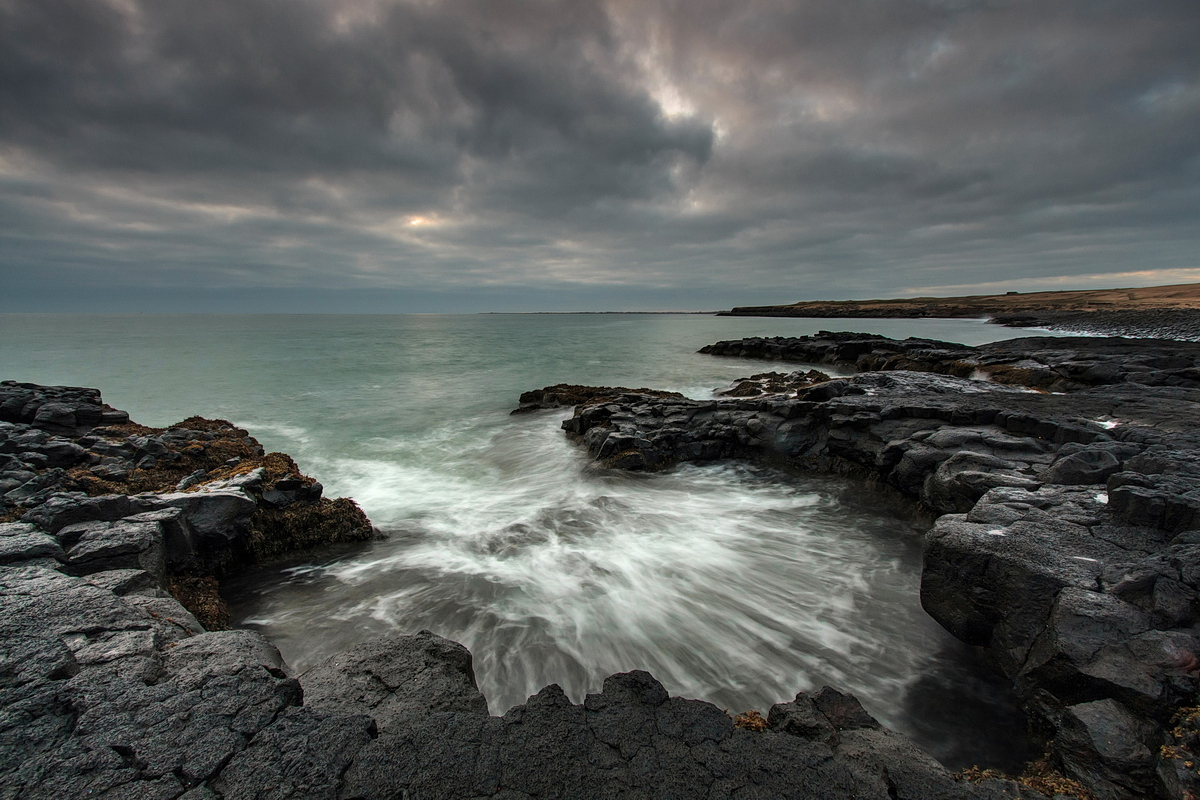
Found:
[328,657,1012,800]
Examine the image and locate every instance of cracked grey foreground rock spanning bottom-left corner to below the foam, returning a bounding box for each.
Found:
[0,567,1012,800]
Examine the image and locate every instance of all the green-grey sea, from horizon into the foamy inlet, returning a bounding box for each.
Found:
[0,314,1060,768]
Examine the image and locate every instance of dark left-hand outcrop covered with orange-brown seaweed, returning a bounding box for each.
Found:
[0,381,373,627]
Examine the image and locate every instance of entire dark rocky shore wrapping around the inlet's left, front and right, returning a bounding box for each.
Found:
[0,326,1200,800]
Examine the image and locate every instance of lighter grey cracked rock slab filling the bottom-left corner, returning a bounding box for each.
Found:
[0,567,309,798]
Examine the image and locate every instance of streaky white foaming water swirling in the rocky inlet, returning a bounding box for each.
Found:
[229,414,941,729]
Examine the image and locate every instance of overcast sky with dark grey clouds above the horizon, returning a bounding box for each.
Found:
[0,0,1200,313]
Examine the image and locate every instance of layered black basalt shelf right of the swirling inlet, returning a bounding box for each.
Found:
[542,333,1200,799]
